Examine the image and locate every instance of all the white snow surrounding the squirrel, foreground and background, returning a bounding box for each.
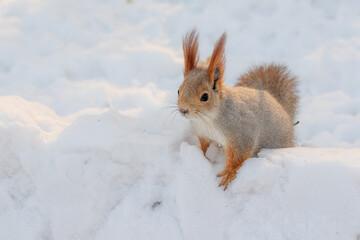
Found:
[0,0,360,239]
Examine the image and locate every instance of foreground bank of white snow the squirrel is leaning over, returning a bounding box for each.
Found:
[0,97,360,239]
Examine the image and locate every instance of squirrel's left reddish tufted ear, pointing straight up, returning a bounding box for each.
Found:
[183,29,199,75]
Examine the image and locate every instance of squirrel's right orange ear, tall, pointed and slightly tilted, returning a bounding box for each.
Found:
[207,33,226,90]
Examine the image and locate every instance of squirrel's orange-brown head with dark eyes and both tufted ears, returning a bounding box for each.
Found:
[178,29,226,118]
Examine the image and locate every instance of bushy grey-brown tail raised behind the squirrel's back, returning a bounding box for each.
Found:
[236,64,299,120]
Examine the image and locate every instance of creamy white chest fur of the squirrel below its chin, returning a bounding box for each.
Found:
[190,116,226,146]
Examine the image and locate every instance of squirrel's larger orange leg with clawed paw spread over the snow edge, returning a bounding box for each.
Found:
[217,146,253,190]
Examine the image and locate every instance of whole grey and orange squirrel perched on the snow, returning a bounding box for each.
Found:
[178,30,299,190]
